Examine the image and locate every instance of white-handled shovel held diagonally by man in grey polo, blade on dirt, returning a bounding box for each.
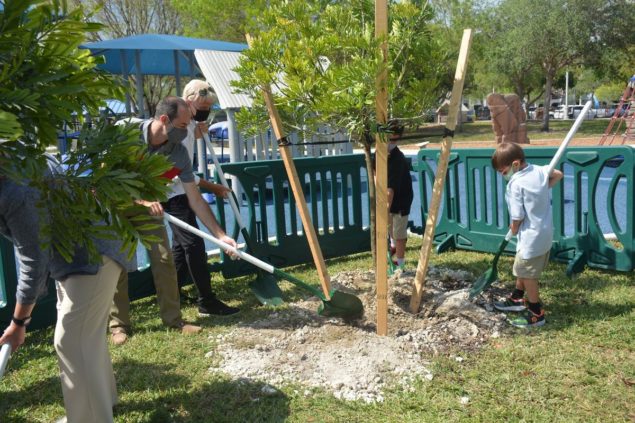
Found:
[164,213,364,319]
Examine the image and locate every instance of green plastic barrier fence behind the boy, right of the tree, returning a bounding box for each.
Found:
[413,146,635,275]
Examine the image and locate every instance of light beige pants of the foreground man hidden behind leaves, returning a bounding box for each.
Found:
[54,256,121,423]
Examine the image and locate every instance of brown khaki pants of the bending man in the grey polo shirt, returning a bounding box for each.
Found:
[109,225,183,330]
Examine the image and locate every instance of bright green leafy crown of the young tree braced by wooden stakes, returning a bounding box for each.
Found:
[235,0,445,142]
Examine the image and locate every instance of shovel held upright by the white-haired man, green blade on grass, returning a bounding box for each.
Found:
[203,134,283,306]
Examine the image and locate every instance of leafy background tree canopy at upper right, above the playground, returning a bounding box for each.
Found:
[464,0,635,112]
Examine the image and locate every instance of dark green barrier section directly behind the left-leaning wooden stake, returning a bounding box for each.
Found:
[217,155,370,277]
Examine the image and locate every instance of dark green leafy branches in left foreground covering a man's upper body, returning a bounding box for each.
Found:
[0,0,168,259]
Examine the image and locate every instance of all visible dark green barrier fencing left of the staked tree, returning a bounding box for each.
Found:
[0,155,370,329]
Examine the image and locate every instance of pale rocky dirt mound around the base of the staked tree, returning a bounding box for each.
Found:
[208,267,506,403]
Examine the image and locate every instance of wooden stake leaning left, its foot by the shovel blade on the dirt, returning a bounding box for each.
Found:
[246,34,331,301]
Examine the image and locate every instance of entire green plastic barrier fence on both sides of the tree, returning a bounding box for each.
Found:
[0,147,635,329]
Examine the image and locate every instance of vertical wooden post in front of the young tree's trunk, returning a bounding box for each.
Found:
[376,0,388,336]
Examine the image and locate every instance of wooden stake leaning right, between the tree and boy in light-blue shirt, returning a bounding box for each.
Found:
[410,29,472,314]
